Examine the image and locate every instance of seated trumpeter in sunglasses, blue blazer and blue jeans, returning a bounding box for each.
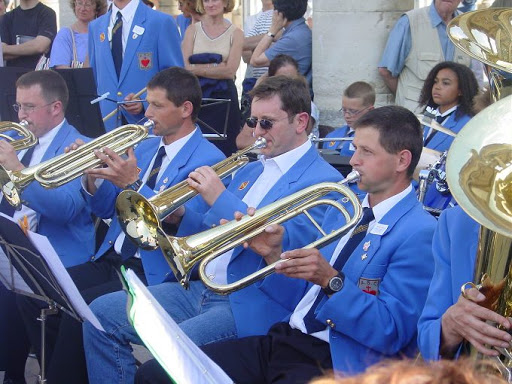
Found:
[84,76,341,383]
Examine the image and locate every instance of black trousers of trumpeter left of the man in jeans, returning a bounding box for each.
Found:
[18,249,146,384]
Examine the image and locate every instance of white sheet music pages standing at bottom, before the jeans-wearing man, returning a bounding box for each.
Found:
[123,269,233,384]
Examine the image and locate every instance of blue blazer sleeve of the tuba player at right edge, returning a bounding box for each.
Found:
[418,206,480,360]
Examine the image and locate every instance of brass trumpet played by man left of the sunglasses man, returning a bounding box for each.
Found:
[0,120,154,210]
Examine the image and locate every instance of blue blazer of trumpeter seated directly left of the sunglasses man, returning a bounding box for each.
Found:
[83,129,224,285]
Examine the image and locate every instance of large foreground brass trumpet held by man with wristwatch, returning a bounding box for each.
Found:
[157,171,362,295]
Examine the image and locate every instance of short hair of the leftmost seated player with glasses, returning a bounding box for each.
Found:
[16,69,69,111]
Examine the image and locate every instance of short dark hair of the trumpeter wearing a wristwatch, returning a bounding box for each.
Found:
[353,105,423,177]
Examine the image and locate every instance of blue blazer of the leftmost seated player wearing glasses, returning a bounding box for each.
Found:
[21,121,95,267]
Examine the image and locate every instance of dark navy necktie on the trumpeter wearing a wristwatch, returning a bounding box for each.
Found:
[304,207,375,334]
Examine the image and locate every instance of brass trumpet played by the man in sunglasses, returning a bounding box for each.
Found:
[116,137,267,250]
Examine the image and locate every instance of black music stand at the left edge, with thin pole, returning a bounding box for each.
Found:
[0,215,83,383]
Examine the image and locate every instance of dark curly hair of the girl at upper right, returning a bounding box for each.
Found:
[419,61,478,117]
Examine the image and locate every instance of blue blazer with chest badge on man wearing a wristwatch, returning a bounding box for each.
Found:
[316,191,436,373]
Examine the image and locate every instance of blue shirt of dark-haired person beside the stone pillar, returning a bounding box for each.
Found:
[265,17,313,86]
